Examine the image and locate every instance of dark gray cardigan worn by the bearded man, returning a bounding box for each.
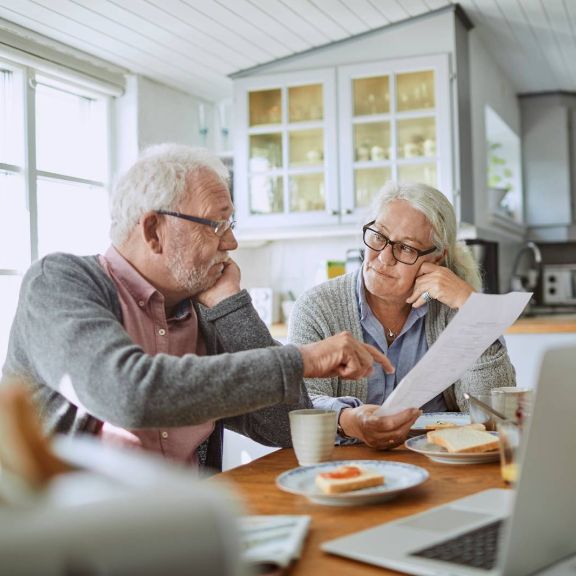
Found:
[3,254,310,468]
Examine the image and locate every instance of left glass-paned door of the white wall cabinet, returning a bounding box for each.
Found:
[234,69,339,230]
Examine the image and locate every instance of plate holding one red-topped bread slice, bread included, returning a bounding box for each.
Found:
[276,460,428,506]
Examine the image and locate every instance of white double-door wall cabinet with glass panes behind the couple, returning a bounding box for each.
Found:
[234,55,453,231]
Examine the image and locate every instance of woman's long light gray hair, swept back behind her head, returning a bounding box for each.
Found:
[372,182,482,291]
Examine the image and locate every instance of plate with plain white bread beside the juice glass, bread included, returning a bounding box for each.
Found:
[406,424,500,464]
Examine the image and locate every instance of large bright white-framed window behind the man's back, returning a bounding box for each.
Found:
[0,60,109,365]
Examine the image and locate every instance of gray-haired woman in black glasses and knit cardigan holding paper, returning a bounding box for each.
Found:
[289,182,515,448]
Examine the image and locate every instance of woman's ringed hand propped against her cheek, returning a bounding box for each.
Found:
[406,262,474,308]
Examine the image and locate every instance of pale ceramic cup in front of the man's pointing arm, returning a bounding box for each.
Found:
[289,408,337,466]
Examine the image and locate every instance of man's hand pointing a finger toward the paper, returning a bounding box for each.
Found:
[299,332,394,380]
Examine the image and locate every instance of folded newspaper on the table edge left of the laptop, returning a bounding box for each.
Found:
[239,515,310,568]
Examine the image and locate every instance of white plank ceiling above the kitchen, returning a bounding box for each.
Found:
[0,0,576,100]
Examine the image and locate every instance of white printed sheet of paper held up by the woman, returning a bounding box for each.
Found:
[375,292,532,416]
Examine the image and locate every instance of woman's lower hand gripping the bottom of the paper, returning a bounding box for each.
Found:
[340,404,422,450]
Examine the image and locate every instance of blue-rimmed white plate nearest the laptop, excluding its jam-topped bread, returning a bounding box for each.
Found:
[276,460,429,506]
